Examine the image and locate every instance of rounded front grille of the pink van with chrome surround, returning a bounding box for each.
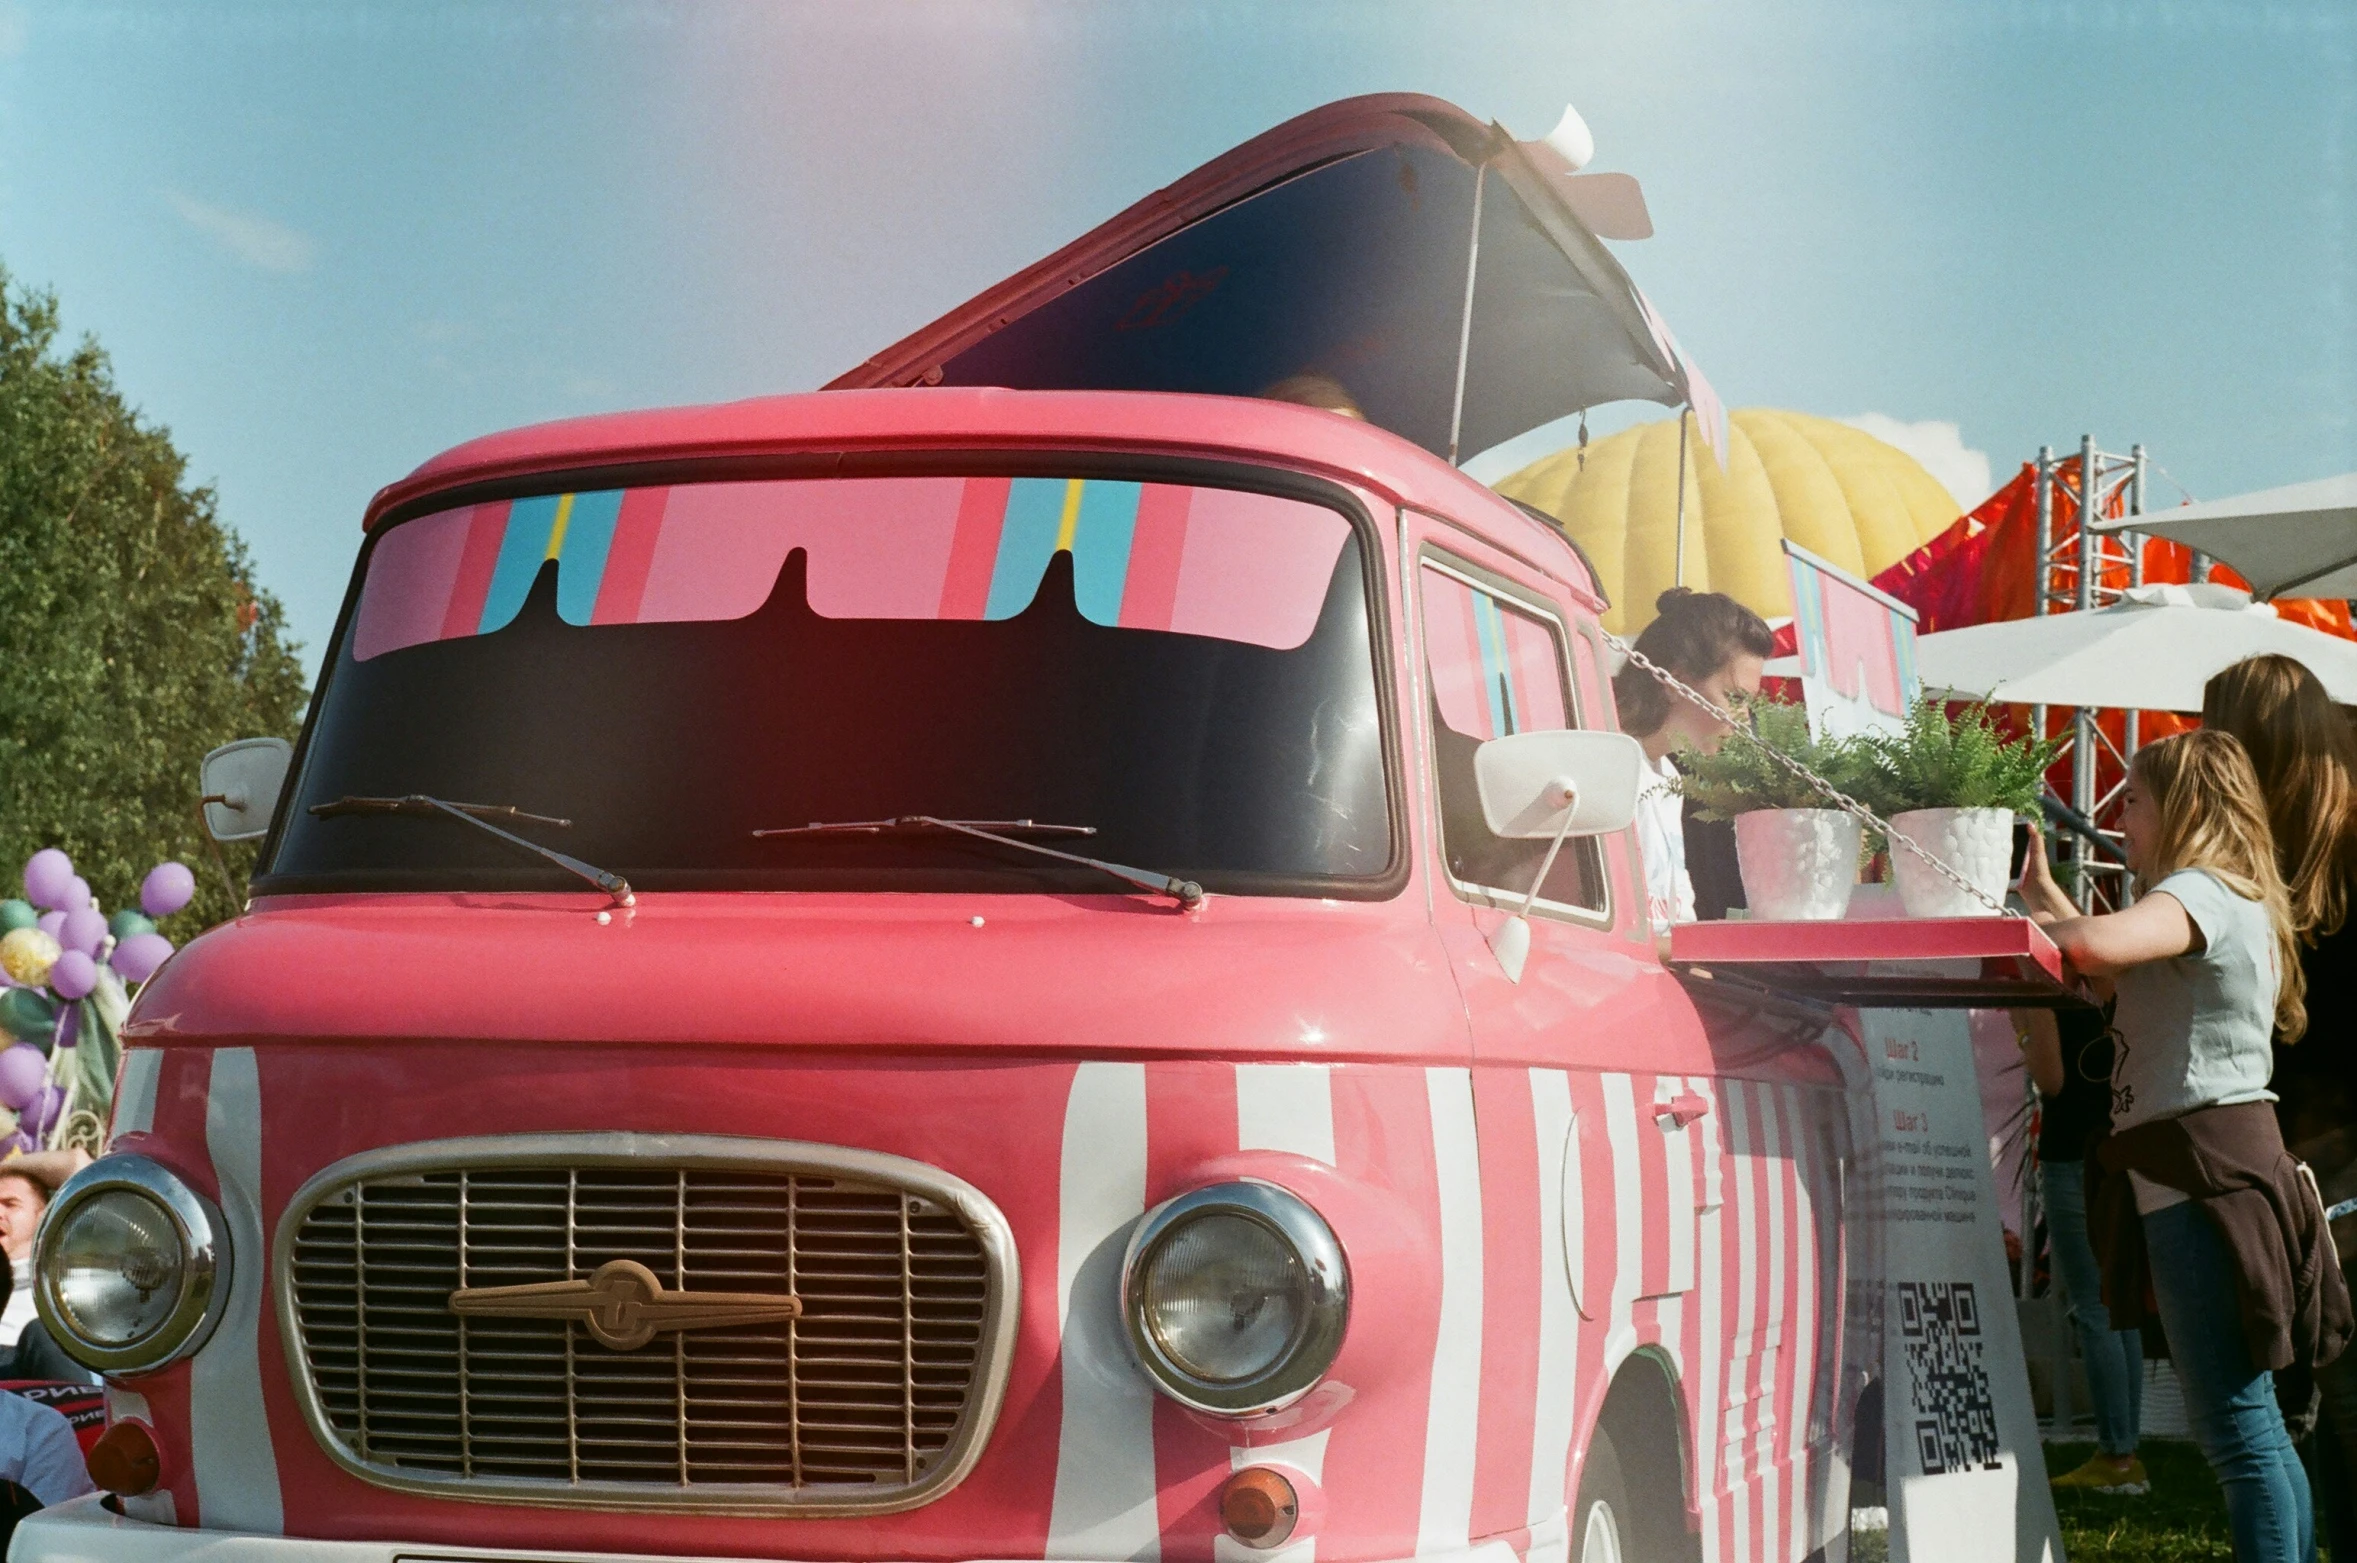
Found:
[271,1134,1021,1516]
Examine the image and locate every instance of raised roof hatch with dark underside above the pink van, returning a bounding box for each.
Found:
[827,92,1725,460]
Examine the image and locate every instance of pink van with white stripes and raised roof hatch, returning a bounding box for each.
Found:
[12,99,1860,1563]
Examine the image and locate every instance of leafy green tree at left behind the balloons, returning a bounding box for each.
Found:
[0,269,304,938]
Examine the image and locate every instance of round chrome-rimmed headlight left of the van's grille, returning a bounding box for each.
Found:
[33,1155,229,1372]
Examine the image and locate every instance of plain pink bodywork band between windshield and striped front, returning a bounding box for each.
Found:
[127,893,1466,1063]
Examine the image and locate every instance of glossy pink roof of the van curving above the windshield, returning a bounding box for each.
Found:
[363,387,1603,608]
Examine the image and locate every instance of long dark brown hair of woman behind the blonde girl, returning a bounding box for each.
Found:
[2201,655,2357,943]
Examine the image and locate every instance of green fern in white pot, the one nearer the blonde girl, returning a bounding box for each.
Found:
[1860,700,2062,917]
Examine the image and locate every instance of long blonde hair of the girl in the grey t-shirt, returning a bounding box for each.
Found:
[2133,728,2308,1042]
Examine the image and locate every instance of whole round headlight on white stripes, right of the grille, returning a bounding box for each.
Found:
[1122,1183,1351,1417]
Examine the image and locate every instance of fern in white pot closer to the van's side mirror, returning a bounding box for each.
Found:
[1678,700,1864,922]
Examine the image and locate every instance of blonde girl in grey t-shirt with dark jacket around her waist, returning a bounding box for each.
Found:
[2022,731,2350,1563]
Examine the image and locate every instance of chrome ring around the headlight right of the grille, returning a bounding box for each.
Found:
[1122,1181,1351,1417]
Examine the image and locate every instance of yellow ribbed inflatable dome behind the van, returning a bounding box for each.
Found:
[1497,408,1963,634]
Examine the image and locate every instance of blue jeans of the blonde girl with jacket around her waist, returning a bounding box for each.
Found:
[2145,1202,2317,1563]
